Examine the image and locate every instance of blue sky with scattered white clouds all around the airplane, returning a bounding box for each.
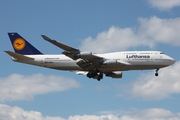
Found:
[0,0,180,120]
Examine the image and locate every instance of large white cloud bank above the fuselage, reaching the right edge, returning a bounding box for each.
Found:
[80,16,180,53]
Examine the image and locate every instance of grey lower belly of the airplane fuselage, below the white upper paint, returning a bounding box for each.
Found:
[17,60,168,72]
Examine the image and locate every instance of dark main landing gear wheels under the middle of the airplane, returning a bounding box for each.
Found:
[87,71,103,81]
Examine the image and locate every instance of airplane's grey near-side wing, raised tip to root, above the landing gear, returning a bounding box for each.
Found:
[41,35,128,71]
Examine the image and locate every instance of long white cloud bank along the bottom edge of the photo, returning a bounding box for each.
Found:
[0,104,180,120]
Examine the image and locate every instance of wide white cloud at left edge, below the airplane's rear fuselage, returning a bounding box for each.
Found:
[0,74,80,101]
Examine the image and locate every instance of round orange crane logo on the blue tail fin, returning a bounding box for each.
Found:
[13,38,26,50]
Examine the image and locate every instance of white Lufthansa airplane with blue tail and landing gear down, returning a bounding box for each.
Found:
[5,32,175,81]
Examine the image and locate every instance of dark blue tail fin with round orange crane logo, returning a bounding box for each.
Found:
[8,33,42,55]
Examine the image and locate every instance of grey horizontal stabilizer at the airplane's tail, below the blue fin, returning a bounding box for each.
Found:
[4,51,34,60]
